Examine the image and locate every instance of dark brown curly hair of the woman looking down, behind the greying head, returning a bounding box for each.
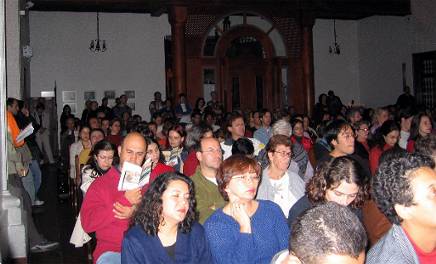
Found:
[306,156,369,208]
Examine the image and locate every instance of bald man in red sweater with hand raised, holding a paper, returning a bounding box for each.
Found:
[80,132,147,264]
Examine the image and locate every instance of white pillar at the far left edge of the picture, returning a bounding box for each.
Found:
[0,0,27,259]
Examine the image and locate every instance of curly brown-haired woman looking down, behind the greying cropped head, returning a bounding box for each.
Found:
[288,156,368,226]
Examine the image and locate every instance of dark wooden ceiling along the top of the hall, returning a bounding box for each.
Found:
[30,0,410,19]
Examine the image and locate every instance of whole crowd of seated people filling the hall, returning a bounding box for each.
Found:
[40,89,436,263]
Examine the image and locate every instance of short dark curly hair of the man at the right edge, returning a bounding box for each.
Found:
[372,153,435,225]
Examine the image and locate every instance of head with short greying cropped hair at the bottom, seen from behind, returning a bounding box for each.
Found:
[271,202,367,264]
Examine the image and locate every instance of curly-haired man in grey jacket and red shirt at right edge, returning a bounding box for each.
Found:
[366,153,436,264]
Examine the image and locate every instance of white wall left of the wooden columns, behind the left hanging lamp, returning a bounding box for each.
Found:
[30,12,171,118]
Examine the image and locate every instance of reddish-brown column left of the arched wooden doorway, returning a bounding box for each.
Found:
[169,6,187,98]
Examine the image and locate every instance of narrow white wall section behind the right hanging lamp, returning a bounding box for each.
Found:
[313,19,361,104]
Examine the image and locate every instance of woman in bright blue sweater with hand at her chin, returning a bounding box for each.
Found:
[204,155,289,264]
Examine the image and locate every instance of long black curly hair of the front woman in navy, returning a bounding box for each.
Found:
[130,172,198,236]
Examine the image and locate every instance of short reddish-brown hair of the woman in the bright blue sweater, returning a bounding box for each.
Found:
[216,154,262,201]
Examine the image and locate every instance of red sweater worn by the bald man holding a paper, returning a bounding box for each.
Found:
[80,167,147,263]
